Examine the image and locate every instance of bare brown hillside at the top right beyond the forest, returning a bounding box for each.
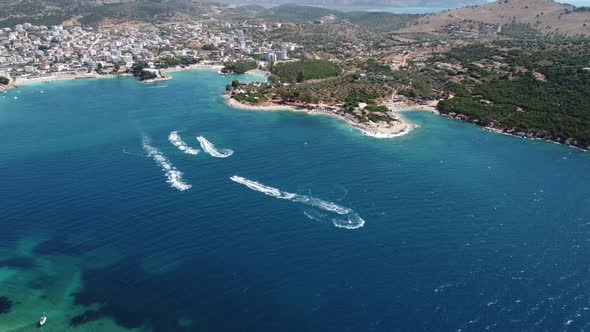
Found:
[401,0,590,36]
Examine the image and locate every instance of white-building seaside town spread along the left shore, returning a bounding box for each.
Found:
[0,22,298,89]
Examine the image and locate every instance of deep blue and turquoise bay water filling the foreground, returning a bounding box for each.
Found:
[0,71,590,331]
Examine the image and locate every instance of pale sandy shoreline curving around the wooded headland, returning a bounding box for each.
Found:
[223,93,418,138]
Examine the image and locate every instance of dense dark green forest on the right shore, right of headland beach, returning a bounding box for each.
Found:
[439,46,590,148]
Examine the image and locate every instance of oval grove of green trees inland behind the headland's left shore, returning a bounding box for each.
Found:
[271,60,340,82]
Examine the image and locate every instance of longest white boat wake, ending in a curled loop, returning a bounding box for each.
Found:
[230,175,365,229]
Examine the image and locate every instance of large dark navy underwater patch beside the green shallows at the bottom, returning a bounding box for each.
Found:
[74,257,286,332]
